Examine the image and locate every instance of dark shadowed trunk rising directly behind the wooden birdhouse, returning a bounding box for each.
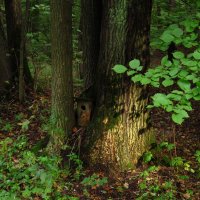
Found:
[81,0,101,89]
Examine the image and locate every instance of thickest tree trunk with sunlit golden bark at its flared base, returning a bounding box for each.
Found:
[85,0,154,171]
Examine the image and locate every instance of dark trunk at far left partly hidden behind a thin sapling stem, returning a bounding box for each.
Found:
[5,0,32,83]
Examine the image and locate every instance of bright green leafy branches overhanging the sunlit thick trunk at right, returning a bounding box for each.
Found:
[113,20,200,124]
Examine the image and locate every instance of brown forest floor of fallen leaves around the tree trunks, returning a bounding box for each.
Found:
[0,52,200,200]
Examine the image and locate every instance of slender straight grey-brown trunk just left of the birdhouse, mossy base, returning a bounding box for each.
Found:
[47,0,74,154]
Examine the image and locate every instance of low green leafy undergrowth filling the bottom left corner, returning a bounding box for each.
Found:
[0,137,76,200]
